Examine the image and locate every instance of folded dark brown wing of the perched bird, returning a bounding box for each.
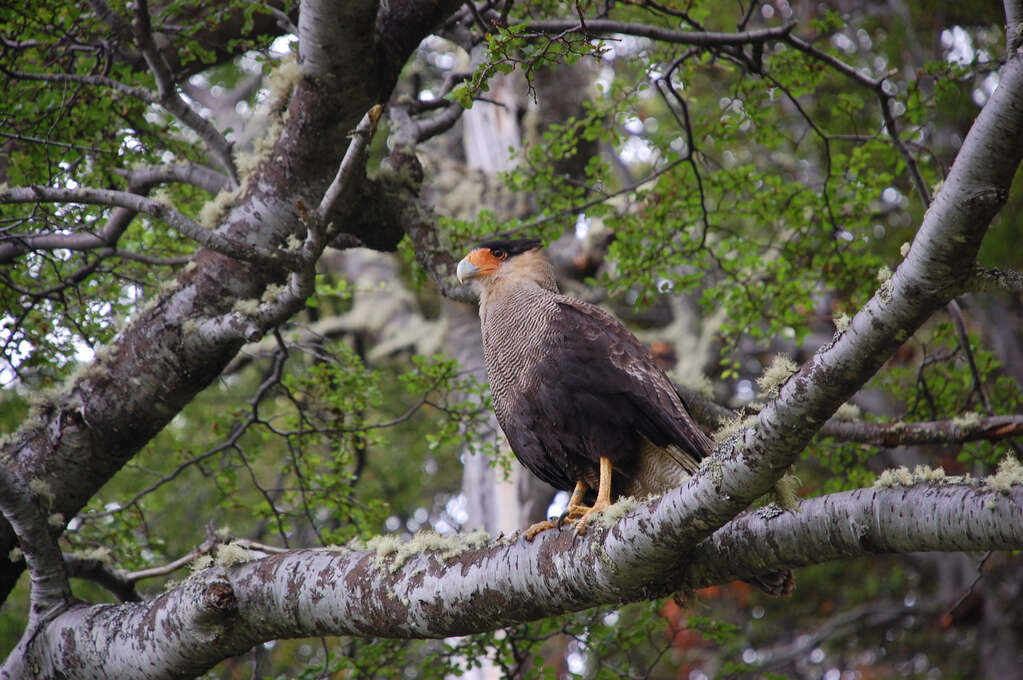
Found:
[523,296,712,467]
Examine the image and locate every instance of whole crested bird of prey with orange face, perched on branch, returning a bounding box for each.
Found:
[457,238,713,540]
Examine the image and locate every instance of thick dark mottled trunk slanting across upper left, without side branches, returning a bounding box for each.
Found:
[0,1,457,609]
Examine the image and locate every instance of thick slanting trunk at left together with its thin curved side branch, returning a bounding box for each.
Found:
[0,0,451,638]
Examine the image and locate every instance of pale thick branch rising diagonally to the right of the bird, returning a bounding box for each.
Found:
[621,49,1023,569]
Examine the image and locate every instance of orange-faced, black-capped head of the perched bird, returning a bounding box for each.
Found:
[456,238,558,291]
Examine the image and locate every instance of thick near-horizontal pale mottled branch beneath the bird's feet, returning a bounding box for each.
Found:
[9,485,1023,680]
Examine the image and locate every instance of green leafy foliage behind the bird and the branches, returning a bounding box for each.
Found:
[0,0,1020,678]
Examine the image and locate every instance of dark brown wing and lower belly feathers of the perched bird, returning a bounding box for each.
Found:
[502,298,711,490]
